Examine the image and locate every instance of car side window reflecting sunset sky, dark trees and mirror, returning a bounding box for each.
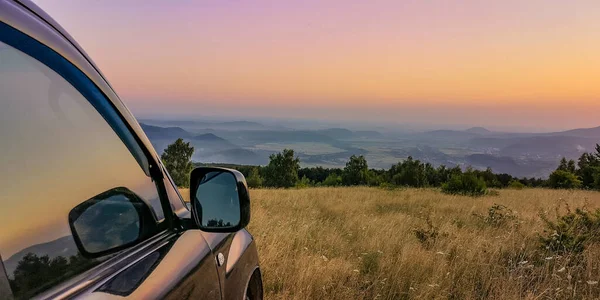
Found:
[0,42,164,298]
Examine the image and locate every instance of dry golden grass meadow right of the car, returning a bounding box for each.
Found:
[184,187,600,299]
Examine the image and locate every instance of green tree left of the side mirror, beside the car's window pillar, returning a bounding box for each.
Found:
[160,139,194,187]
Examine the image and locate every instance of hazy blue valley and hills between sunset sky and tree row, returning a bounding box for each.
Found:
[140,119,600,177]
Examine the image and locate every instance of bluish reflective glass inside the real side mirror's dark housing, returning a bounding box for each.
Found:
[195,171,241,228]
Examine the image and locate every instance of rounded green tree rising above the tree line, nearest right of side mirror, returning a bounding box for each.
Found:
[263,149,300,188]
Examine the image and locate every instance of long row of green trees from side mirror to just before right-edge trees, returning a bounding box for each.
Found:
[229,149,546,194]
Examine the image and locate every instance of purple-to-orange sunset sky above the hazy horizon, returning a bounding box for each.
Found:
[35,0,600,130]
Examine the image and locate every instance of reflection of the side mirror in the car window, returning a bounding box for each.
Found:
[69,187,157,258]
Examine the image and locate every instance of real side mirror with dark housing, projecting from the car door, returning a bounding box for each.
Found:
[190,167,250,232]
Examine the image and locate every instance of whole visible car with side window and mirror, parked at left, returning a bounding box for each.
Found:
[0,0,263,299]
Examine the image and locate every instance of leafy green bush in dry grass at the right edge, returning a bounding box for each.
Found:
[540,208,600,254]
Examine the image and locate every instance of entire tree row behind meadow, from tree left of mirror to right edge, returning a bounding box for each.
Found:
[162,139,600,195]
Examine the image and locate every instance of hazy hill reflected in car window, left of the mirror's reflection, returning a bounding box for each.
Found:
[4,235,79,277]
